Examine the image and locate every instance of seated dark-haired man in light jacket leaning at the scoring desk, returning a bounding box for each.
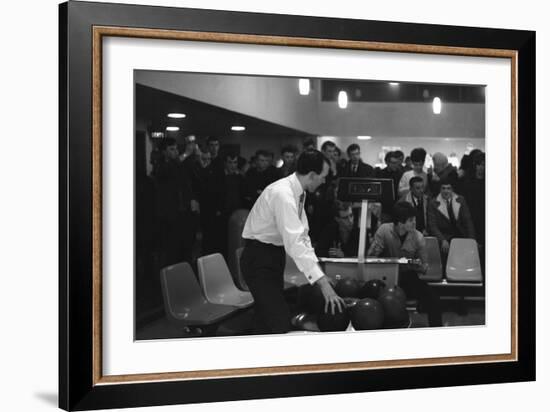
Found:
[368,202,443,326]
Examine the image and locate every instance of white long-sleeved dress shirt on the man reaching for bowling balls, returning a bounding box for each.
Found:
[242,173,324,284]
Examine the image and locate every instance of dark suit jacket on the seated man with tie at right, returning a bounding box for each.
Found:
[428,193,475,242]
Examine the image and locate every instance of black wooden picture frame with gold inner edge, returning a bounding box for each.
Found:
[59,1,535,410]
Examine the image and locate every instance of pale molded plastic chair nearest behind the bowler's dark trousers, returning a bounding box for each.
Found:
[197,253,254,308]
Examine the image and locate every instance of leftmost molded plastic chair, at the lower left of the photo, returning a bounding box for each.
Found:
[160,262,237,326]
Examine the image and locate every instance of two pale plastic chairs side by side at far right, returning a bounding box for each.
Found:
[420,237,483,283]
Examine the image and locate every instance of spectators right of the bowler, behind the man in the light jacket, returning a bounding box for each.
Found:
[309,141,485,274]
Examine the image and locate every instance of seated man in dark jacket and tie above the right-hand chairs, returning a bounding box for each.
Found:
[428,179,475,268]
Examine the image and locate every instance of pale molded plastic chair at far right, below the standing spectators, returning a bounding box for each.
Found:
[447,238,483,282]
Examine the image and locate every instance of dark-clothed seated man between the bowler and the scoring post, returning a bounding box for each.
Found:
[315,200,359,258]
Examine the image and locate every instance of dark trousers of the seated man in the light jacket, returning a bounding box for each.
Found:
[399,271,443,326]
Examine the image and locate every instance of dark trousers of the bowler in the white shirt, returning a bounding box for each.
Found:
[241,240,290,334]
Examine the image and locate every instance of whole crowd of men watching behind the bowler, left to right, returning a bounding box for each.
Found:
[148,136,485,276]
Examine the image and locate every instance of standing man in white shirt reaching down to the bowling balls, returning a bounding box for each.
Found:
[241,150,344,333]
